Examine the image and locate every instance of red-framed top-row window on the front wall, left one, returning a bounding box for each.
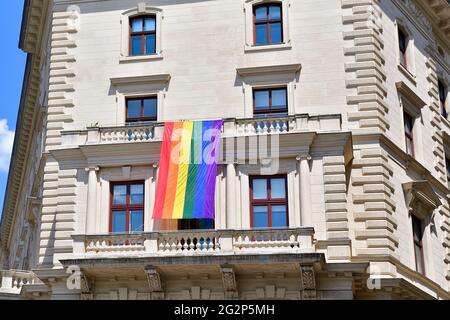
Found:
[130,15,156,56]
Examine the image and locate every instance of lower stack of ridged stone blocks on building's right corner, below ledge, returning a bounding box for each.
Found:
[352,148,399,256]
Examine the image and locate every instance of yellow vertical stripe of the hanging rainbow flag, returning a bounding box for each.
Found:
[172,122,194,219]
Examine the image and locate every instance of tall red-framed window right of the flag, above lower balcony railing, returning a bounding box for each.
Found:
[250,176,288,228]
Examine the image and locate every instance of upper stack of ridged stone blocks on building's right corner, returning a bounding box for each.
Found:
[342,0,389,133]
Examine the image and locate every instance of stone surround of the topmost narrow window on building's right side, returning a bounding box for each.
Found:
[394,18,417,85]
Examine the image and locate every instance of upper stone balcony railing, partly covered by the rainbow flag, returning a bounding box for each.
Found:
[62,114,341,145]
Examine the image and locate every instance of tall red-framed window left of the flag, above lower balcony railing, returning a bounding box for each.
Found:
[110,182,144,233]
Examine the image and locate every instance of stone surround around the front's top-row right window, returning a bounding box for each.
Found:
[244,0,292,52]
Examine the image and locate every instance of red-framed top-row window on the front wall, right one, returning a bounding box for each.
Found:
[253,3,283,45]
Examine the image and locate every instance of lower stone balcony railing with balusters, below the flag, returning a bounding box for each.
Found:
[72,228,314,258]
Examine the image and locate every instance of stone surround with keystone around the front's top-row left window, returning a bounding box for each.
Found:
[119,3,164,62]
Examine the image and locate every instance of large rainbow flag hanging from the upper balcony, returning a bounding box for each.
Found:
[153,120,223,219]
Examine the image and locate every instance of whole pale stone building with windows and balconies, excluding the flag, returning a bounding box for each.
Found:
[0,0,450,300]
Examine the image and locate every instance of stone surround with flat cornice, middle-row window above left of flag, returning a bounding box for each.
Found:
[110,74,170,125]
